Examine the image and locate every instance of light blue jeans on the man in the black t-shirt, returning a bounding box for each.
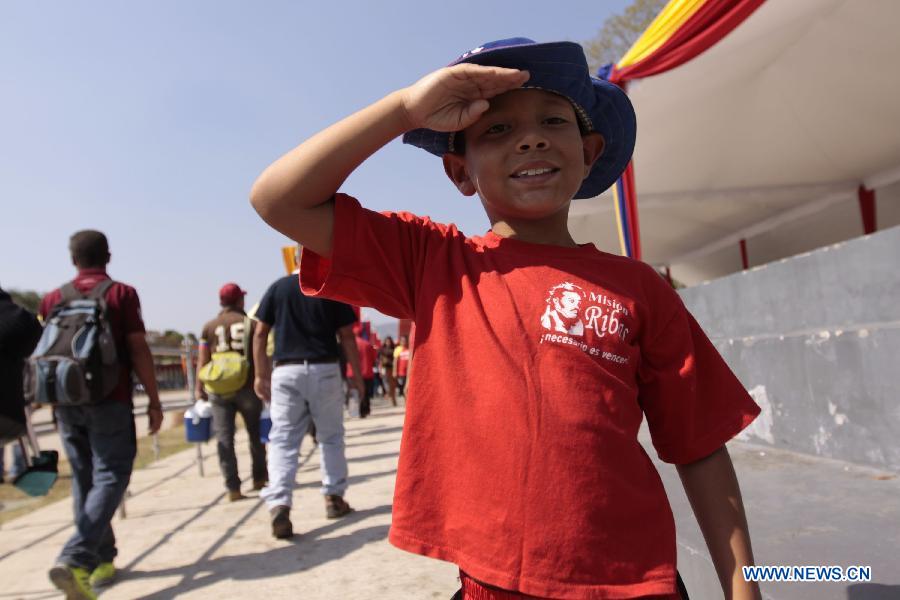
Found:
[260,362,347,509]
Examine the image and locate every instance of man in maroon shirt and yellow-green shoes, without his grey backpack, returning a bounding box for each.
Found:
[38,230,163,599]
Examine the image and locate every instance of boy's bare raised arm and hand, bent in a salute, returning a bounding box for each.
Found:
[250,63,528,257]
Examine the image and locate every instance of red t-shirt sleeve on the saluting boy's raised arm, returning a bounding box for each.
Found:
[300,194,447,319]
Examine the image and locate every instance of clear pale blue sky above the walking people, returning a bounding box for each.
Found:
[0,0,628,332]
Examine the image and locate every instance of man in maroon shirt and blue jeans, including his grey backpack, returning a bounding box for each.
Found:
[35,230,163,598]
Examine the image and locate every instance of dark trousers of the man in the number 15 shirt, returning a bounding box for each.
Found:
[209,387,268,491]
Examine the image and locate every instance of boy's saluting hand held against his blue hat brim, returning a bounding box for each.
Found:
[402,63,529,131]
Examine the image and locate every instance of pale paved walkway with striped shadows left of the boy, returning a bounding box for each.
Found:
[0,404,457,600]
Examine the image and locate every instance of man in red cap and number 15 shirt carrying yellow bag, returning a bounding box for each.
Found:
[197,283,268,502]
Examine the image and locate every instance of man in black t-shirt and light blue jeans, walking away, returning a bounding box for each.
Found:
[253,262,363,539]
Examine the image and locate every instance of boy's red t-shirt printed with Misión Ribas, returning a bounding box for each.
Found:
[300,194,759,598]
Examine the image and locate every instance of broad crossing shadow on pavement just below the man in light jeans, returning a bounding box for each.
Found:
[122,502,391,600]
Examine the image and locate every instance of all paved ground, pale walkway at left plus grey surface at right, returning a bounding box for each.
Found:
[0,394,900,600]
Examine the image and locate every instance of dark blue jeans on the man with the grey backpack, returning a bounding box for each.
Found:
[56,402,137,571]
